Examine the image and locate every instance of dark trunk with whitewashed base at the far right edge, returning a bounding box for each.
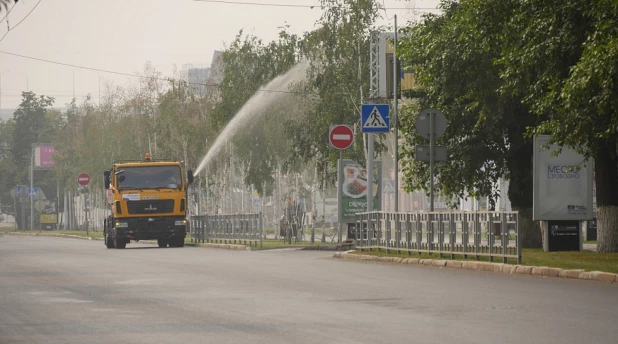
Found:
[594,138,618,253]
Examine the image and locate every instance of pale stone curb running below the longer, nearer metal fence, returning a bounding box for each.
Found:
[333,252,618,284]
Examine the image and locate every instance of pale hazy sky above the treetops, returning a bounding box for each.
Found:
[0,0,439,109]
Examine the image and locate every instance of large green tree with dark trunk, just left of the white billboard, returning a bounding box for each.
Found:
[399,0,541,247]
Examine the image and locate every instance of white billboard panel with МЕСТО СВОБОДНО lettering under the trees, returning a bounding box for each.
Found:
[533,135,594,221]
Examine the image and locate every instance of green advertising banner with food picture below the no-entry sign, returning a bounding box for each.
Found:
[341,160,382,223]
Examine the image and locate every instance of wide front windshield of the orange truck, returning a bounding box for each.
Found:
[116,166,182,190]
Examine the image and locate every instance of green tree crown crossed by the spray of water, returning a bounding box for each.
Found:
[211,28,298,194]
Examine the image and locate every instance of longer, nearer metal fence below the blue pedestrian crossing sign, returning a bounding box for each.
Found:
[351,211,521,264]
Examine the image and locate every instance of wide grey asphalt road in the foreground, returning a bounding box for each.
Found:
[0,235,618,344]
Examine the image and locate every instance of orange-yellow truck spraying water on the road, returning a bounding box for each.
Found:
[103,154,193,248]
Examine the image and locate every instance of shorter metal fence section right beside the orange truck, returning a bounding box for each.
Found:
[190,213,264,248]
